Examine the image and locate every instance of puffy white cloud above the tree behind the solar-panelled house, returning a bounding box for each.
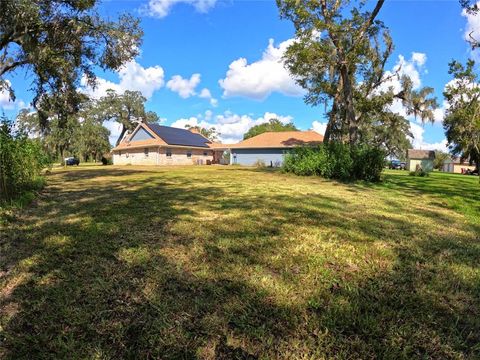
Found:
[81,60,165,99]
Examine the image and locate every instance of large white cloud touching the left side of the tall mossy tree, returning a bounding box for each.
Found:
[219,39,304,100]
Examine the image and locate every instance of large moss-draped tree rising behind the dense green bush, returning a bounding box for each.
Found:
[277,0,436,145]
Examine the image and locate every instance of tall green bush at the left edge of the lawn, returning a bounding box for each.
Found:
[0,119,50,203]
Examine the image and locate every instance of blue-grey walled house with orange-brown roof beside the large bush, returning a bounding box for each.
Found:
[230,131,323,166]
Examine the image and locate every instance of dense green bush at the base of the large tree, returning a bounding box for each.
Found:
[283,143,385,181]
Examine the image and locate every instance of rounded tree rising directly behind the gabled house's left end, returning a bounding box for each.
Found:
[96,90,158,145]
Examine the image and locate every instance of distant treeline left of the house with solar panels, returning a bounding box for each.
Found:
[16,90,158,162]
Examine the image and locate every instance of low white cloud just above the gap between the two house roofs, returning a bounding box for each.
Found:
[171,111,293,144]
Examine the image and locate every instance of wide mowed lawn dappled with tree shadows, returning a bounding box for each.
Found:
[0,166,480,359]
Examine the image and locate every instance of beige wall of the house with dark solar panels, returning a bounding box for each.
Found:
[113,147,213,165]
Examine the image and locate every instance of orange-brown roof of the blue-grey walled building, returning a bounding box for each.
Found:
[231,130,323,149]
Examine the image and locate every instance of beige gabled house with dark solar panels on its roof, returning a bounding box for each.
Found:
[112,123,225,165]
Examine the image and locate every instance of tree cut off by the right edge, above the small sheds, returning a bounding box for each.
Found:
[443,60,480,169]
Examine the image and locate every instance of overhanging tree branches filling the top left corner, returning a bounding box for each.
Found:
[0,0,143,125]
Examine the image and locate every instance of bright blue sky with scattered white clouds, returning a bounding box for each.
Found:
[0,0,480,150]
